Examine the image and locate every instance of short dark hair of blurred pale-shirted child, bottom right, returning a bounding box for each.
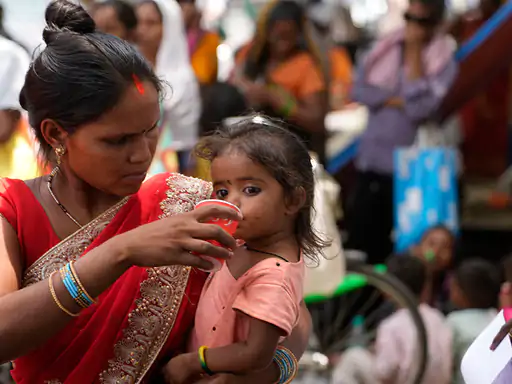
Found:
[454,259,501,309]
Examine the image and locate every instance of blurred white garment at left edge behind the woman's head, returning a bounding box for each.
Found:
[0,36,30,110]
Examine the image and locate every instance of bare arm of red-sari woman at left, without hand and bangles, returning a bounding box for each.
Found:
[0,217,126,362]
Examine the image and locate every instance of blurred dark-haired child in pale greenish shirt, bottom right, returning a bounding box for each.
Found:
[448,259,500,384]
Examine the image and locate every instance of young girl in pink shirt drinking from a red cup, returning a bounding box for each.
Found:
[165,115,327,384]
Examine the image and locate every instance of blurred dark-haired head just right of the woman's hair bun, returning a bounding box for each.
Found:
[92,0,137,42]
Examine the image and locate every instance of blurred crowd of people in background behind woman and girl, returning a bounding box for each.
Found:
[0,0,512,384]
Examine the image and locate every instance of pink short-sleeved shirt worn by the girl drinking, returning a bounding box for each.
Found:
[189,258,305,351]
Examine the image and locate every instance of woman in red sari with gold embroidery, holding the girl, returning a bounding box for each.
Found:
[0,0,308,384]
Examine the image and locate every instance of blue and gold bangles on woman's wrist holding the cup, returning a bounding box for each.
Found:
[48,262,96,317]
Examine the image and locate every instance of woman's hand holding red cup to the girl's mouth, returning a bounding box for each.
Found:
[109,204,242,270]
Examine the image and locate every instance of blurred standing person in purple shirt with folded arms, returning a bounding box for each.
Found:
[347,0,457,264]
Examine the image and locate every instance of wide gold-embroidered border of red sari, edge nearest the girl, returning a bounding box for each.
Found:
[100,174,212,384]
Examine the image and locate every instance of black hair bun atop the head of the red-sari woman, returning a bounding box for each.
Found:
[43,0,96,44]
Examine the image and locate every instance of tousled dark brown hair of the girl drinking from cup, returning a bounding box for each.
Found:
[196,114,330,262]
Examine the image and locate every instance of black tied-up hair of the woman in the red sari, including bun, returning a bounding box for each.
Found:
[20,0,162,161]
